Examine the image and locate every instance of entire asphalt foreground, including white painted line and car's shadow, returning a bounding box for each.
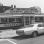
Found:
[0,35,44,44]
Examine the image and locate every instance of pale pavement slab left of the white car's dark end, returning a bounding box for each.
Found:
[0,30,18,38]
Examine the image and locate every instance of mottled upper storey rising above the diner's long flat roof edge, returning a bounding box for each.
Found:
[5,6,41,14]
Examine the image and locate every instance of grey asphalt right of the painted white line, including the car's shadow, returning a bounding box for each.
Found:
[13,35,44,44]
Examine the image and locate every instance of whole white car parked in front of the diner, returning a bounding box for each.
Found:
[16,23,44,37]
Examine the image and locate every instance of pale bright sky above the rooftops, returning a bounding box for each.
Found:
[0,0,44,13]
